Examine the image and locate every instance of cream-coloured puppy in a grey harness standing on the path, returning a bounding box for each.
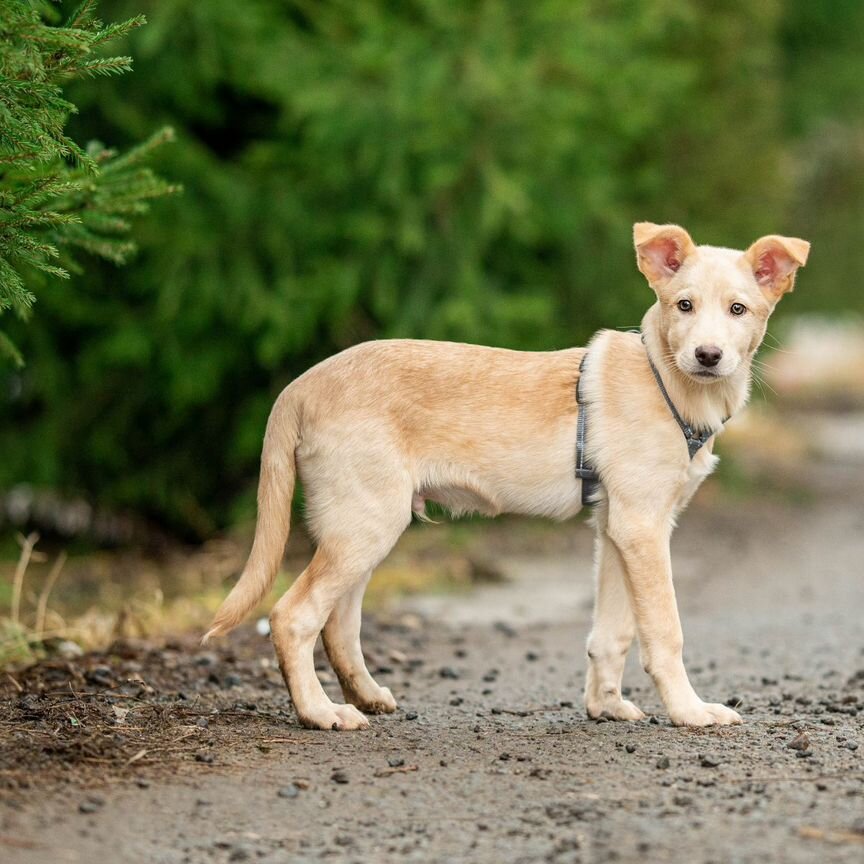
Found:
[205,222,809,729]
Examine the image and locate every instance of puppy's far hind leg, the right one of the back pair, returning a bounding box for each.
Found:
[323,572,396,714]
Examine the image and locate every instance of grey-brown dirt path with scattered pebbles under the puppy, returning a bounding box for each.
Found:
[0,448,864,864]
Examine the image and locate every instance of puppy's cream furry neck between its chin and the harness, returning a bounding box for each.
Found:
[642,303,752,429]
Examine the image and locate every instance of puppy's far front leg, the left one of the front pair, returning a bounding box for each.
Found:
[585,527,645,720]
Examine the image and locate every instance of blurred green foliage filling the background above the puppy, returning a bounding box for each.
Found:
[0,0,864,536]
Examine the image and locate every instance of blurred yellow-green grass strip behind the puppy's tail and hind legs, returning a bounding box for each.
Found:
[0,519,540,668]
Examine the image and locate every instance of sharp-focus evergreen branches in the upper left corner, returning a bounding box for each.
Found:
[0,0,172,363]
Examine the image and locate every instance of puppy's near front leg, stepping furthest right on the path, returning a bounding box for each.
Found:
[607,504,741,726]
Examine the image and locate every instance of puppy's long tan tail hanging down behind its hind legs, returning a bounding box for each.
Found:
[201,391,300,644]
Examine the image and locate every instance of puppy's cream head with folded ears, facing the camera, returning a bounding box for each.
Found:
[633,222,810,383]
